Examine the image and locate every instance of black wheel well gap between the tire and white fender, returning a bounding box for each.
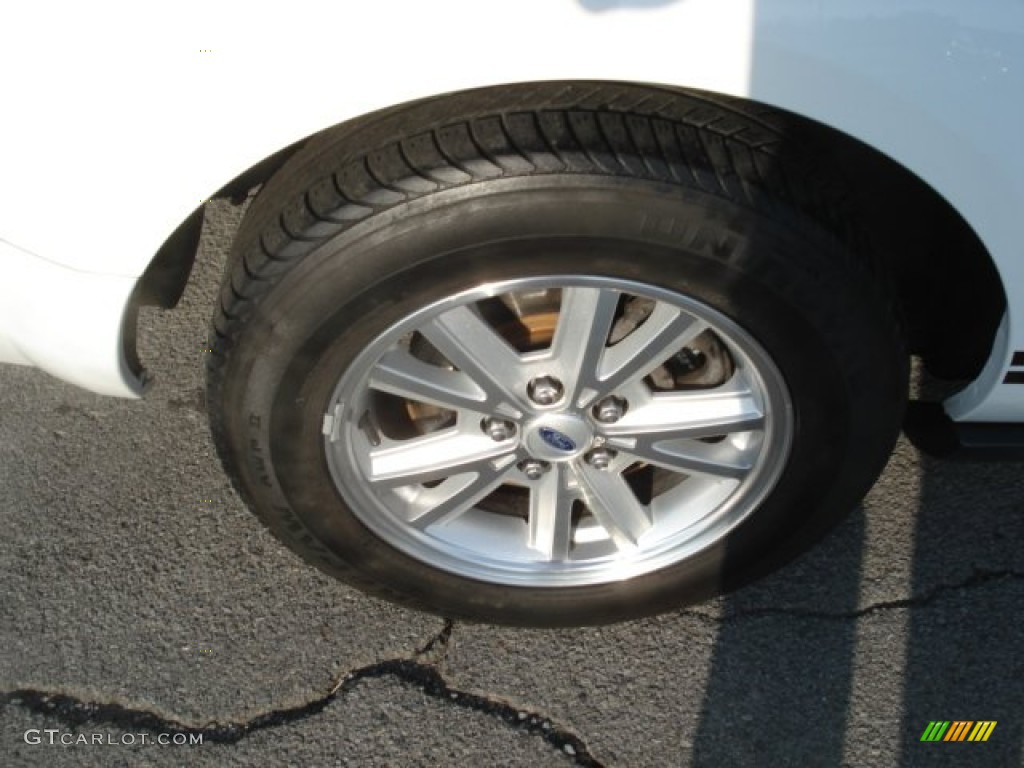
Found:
[134,86,1007,380]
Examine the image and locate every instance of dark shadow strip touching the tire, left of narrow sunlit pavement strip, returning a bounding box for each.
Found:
[693,499,864,767]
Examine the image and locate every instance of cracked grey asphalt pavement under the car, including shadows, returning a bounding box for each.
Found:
[0,204,1024,768]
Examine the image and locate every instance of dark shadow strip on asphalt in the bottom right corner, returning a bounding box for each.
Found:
[900,460,1024,766]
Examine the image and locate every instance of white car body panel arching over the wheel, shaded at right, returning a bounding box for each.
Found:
[0,0,1024,421]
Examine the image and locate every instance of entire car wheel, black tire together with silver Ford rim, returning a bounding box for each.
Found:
[209,85,906,626]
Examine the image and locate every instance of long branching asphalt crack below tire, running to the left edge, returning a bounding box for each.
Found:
[0,620,603,768]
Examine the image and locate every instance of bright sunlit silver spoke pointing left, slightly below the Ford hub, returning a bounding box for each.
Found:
[370,427,515,487]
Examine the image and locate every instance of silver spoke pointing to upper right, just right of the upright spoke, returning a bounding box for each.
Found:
[597,302,708,394]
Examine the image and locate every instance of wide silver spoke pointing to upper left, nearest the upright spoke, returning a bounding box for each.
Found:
[419,306,527,415]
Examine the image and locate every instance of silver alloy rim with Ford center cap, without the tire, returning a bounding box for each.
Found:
[324,276,794,588]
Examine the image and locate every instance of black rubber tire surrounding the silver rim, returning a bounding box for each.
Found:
[208,83,907,626]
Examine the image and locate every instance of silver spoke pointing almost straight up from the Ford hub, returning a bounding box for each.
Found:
[551,288,621,407]
